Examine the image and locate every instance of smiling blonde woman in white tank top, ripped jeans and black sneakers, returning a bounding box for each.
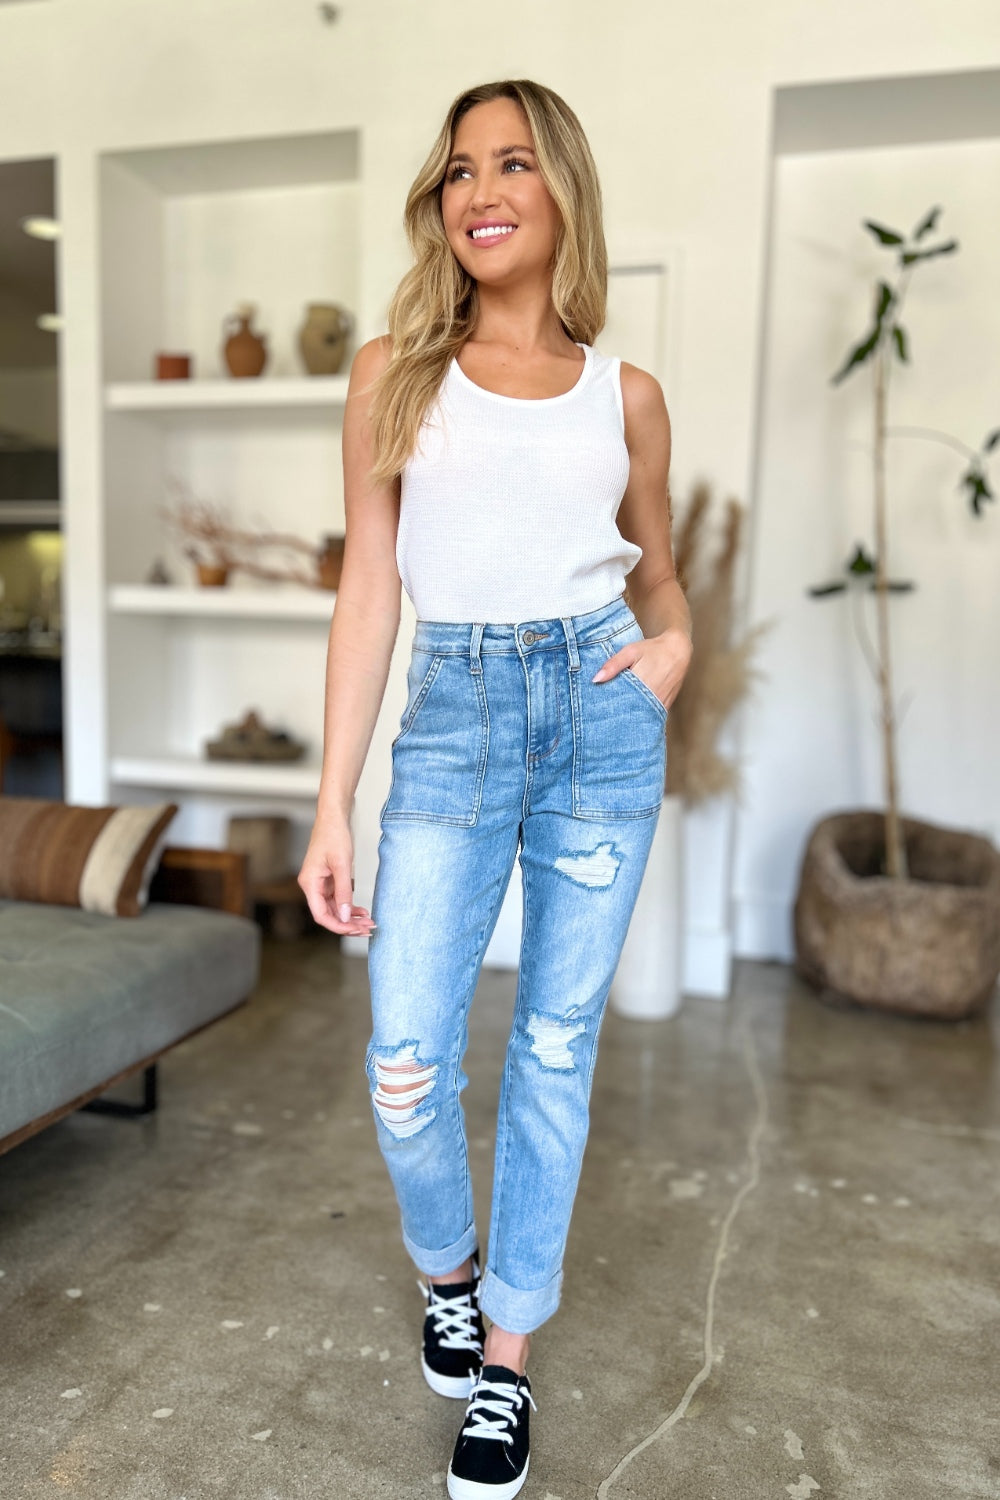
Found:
[300,81,691,1500]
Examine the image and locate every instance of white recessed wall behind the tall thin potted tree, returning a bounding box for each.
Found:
[735,141,1000,957]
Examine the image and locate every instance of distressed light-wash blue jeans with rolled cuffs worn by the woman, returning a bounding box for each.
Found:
[366,597,667,1334]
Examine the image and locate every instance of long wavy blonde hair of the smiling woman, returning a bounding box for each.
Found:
[372,78,607,480]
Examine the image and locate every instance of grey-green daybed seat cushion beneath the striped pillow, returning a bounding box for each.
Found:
[0,902,259,1139]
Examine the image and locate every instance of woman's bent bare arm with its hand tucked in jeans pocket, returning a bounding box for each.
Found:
[595,365,693,708]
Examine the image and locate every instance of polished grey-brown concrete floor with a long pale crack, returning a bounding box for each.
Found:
[0,935,1000,1500]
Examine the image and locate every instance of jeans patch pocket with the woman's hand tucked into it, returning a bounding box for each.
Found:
[573,626,667,819]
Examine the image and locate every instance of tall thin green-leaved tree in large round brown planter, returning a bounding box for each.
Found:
[793,209,1000,1019]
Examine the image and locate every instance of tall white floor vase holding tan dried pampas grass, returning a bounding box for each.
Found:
[610,482,772,1020]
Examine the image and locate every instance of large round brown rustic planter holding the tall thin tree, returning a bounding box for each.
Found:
[795,812,1000,1020]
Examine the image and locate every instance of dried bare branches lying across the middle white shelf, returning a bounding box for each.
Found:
[162,480,322,588]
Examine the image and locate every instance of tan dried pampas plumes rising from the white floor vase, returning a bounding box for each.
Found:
[666,482,774,806]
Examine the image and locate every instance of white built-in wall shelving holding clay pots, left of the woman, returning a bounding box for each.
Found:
[99,131,361,843]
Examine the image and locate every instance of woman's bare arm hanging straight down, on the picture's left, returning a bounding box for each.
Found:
[298,339,402,933]
